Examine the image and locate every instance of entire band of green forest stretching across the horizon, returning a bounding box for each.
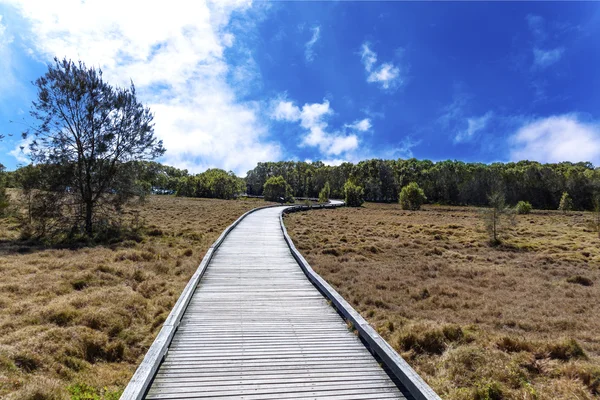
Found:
[4,158,600,210]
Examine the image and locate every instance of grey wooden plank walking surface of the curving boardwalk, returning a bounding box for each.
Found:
[146,207,408,400]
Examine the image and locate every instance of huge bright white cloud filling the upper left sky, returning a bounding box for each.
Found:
[6,0,281,174]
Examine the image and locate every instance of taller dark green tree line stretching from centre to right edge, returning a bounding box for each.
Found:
[246,158,600,210]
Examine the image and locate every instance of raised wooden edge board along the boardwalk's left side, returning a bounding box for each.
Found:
[120,205,281,400]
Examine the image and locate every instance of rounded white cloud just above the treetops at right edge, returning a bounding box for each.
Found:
[510,114,600,165]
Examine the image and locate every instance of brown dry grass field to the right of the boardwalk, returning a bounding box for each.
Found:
[285,203,600,400]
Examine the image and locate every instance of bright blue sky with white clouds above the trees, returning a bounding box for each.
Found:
[0,0,600,175]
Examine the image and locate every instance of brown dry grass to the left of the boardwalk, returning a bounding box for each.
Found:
[0,196,265,400]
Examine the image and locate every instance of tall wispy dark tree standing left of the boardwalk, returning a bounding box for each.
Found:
[23,58,165,237]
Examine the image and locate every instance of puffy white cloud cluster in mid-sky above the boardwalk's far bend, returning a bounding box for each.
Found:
[271,100,360,156]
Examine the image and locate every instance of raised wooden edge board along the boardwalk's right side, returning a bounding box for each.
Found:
[279,202,441,400]
